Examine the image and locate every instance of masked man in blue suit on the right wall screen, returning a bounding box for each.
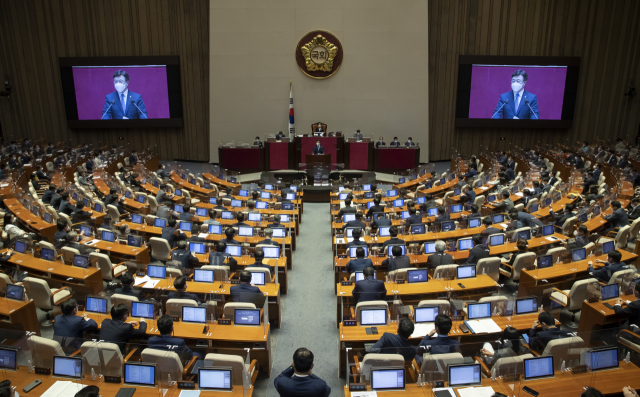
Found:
[491,69,540,120]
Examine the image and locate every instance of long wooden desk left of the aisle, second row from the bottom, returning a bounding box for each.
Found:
[78,312,271,376]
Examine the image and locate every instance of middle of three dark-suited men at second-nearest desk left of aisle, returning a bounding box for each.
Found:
[100,303,147,355]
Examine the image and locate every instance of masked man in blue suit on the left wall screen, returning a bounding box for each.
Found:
[101,70,149,120]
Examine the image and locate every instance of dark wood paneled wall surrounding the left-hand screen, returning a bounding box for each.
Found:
[0,0,209,161]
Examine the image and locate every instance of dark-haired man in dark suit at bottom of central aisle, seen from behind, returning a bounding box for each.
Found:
[273,347,331,397]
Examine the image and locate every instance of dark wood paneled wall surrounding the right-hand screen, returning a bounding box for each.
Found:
[429,0,640,160]
